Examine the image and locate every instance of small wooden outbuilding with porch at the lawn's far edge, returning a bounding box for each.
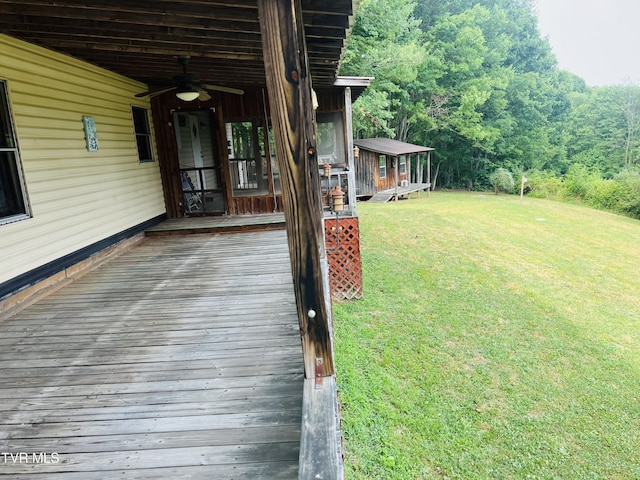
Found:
[353,138,434,202]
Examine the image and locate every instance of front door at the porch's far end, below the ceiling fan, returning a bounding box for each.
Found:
[173,110,227,216]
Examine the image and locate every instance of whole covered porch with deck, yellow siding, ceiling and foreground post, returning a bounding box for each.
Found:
[0,0,358,478]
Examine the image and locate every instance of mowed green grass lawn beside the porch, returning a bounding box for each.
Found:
[334,192,640,480]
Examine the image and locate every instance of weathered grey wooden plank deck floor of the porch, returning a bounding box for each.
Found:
[0,231,303,480]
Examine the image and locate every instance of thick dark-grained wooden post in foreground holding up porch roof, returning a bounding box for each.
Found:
[258,0,334,378]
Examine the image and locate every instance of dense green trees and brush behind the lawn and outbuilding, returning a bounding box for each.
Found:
[340,0,640,217]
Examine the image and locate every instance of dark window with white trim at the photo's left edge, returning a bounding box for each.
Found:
[0,80,28,224]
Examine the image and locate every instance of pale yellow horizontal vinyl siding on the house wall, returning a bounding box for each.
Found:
[0,35,165,283]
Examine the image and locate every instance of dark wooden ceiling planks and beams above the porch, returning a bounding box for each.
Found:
[0,0,353,86]
